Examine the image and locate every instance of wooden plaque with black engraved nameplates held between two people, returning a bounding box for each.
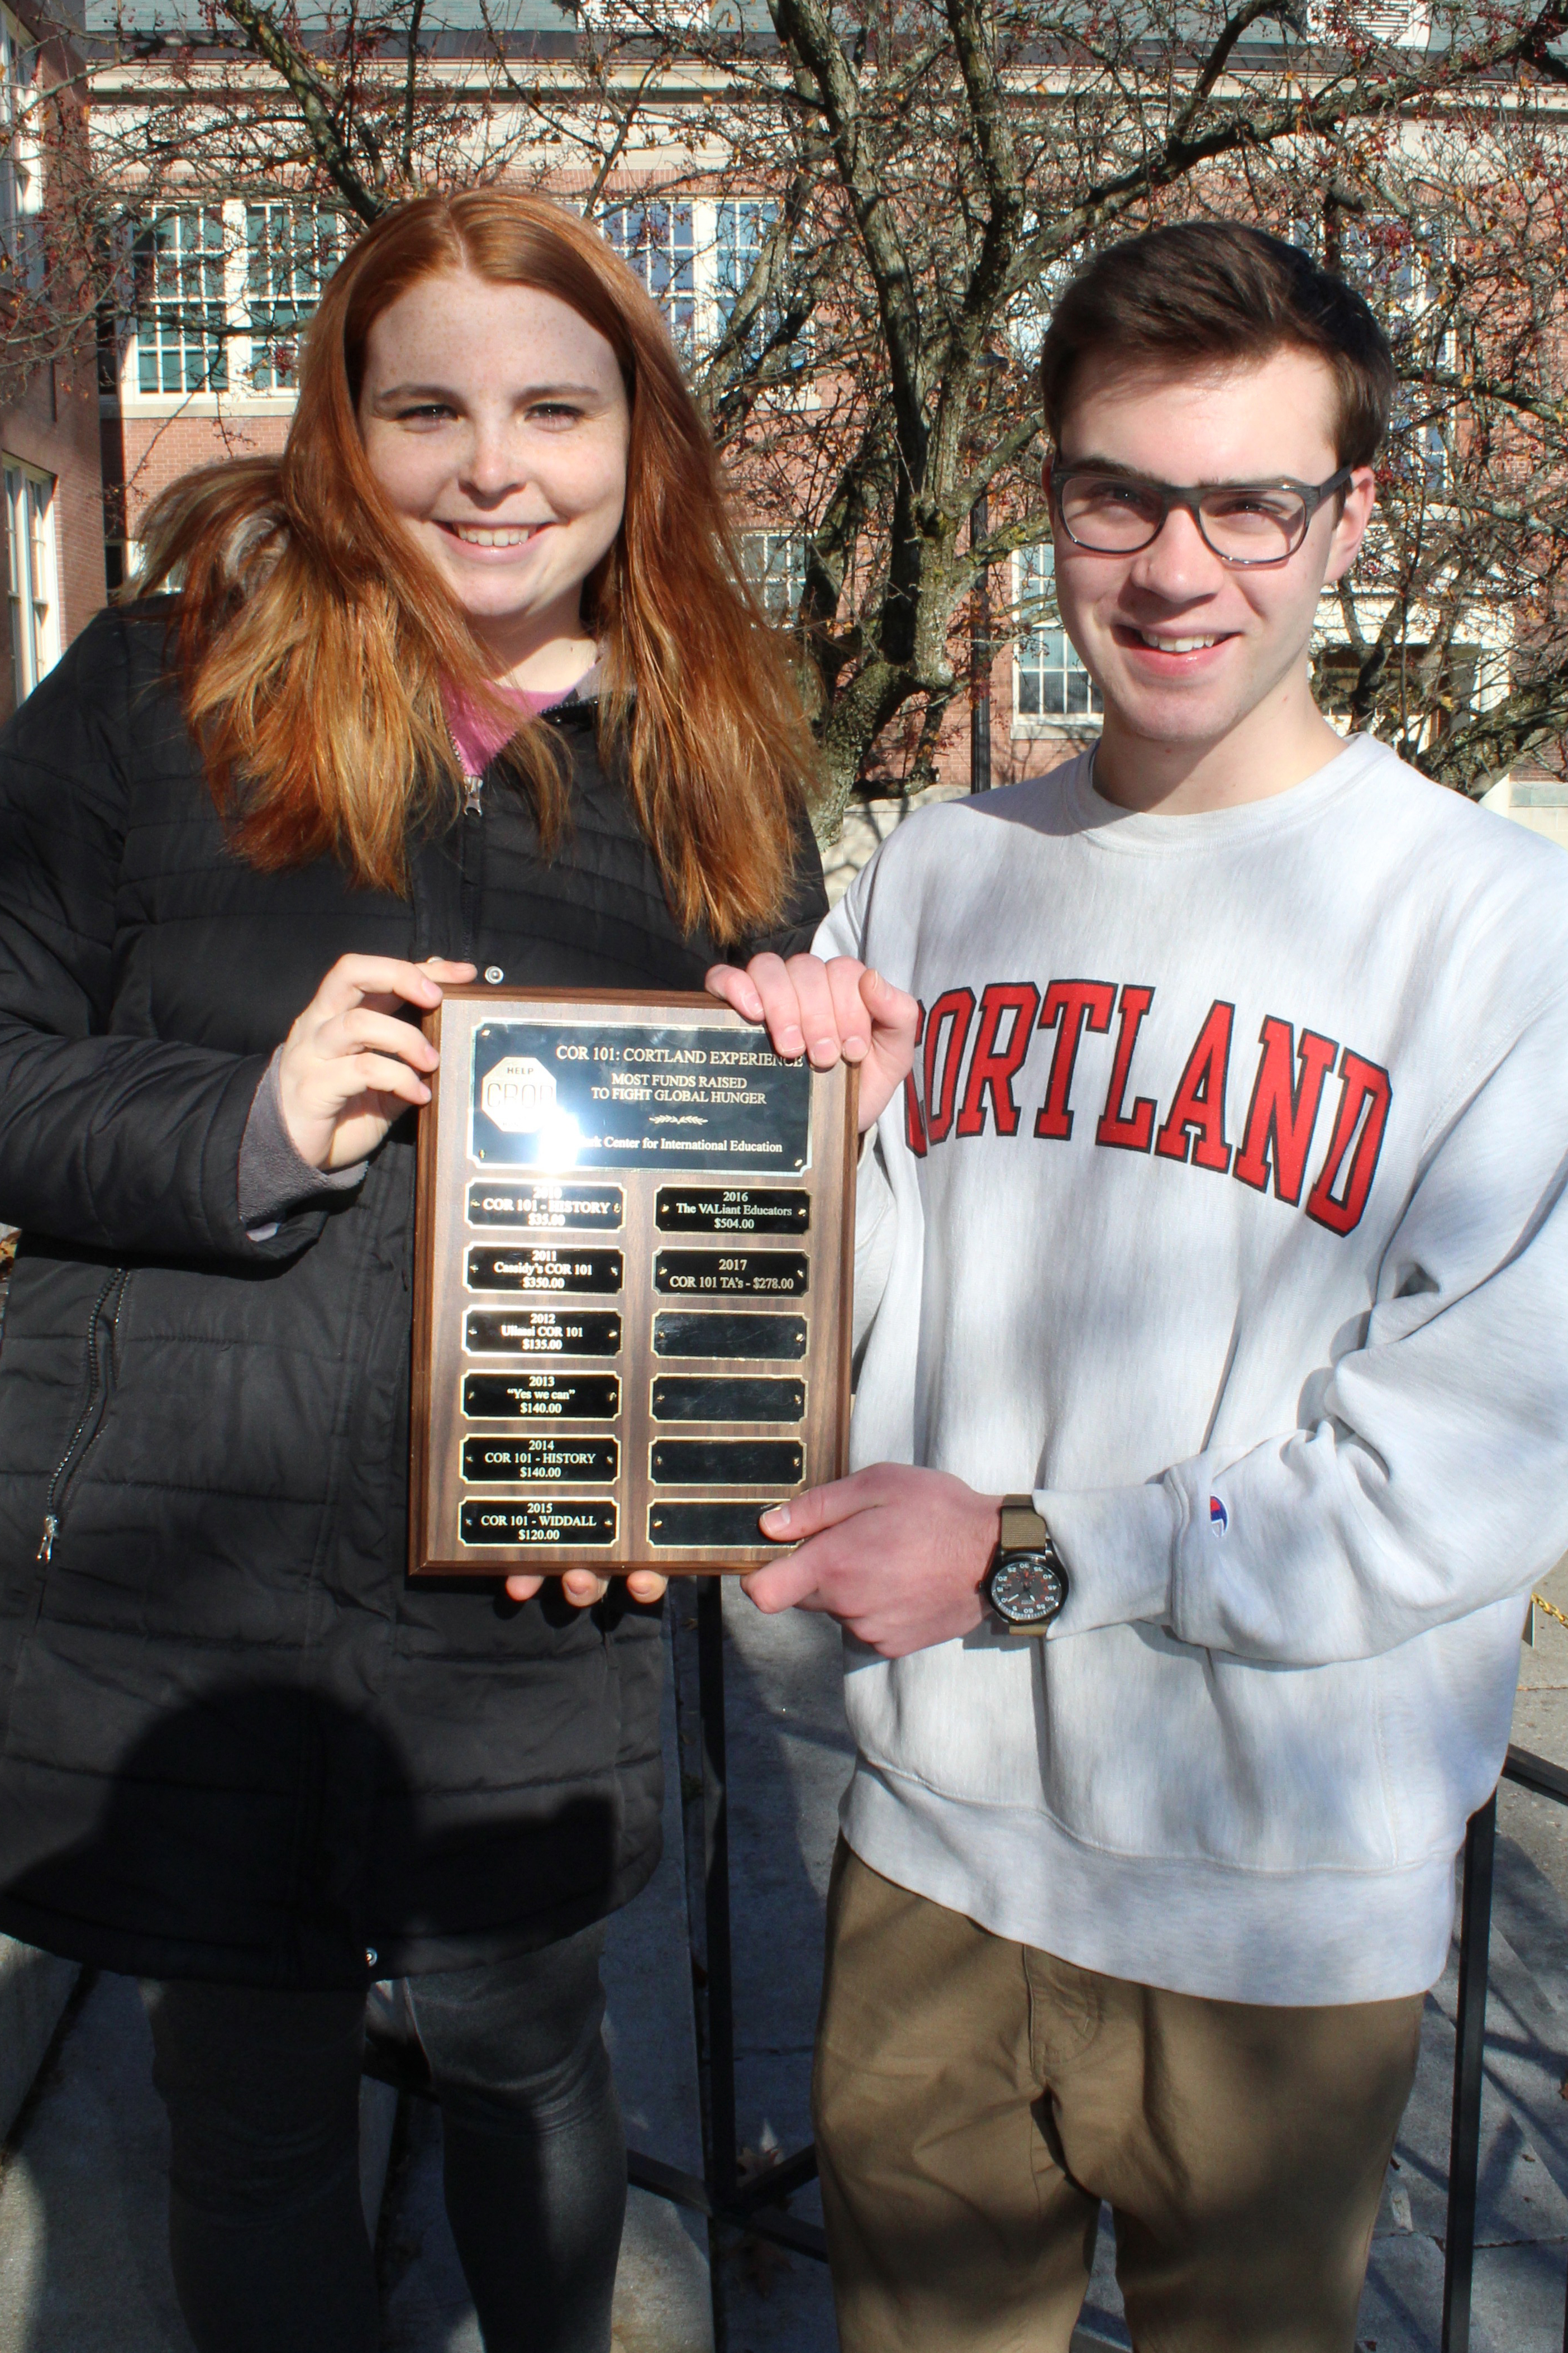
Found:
[409,986,858,1576]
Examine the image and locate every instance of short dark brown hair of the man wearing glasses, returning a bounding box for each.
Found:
[1039,221,1397,466]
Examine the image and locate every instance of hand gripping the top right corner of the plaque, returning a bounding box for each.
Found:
[703,956,919,1134]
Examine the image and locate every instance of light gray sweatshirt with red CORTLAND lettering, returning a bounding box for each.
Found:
[818,739,1568,2003]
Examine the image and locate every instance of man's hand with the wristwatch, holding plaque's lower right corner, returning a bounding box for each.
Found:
[741,1463,1002,1659]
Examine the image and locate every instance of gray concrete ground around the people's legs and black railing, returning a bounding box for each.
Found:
[0,1565,1568,2353]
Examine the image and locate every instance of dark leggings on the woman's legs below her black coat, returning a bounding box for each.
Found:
[144,1927,625,2353]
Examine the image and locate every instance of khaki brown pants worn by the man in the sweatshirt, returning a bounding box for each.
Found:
[813,1840,1422,2353]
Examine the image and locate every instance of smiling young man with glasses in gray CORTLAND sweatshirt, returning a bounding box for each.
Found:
[710,224,1568,2353]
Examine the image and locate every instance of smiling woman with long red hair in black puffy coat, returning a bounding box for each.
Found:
[0,188,823,2353]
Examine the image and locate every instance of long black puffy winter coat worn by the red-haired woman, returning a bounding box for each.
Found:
[0,602,823,1986]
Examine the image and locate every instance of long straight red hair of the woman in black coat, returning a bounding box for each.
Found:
[136,188,813,941]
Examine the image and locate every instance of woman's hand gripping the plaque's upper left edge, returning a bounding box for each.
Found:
[278,956,475,1170]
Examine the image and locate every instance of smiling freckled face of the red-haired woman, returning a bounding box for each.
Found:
[360,270,630,635]
